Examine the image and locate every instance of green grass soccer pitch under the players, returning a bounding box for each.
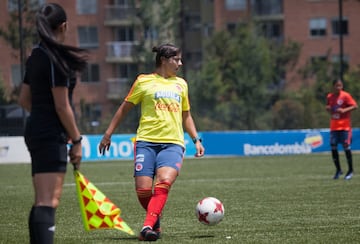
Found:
[0,153,360,244]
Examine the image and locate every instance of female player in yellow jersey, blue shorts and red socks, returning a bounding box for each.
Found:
[99,44,205,241]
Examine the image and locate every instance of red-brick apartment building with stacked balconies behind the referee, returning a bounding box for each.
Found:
[0,0,141,131]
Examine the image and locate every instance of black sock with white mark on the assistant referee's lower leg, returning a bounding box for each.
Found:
[29,206,56,244]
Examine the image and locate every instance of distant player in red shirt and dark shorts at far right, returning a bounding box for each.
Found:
[326,79,357,180]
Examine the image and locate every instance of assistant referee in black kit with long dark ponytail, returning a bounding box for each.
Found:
[19,3,86,244]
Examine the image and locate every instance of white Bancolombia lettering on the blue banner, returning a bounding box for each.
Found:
[244,142,312,156]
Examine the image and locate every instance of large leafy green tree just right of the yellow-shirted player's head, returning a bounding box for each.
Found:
[190,23,300,130]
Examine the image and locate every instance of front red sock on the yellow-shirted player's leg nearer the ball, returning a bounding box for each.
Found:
[144,182,171,226]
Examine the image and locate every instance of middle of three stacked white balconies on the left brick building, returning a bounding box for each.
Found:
[106,41,137,63]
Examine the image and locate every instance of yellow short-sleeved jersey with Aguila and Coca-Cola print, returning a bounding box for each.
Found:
[125,73,190,147]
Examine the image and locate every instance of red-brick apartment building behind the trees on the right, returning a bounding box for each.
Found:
[214,0,360,89]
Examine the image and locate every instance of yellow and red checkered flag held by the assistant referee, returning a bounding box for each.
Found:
[74,170,134,235]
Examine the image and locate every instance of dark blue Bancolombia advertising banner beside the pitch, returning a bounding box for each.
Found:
[203,129,360,156]
